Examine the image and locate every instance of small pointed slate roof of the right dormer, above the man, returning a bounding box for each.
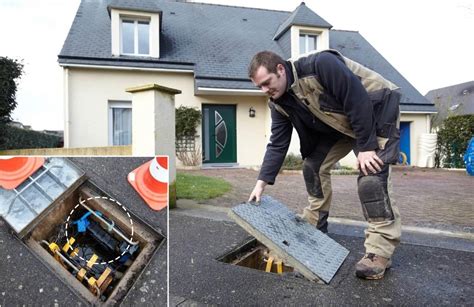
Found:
[273,2,332,39]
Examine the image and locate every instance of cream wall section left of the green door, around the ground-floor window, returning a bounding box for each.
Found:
[64,68,194,147]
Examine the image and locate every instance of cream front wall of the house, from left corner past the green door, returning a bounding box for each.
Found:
[64,68,270,166]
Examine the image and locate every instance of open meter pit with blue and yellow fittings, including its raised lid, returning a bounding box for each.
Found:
[0,158,165,305]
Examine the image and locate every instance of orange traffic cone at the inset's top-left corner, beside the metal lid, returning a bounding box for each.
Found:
[0,157,44,190]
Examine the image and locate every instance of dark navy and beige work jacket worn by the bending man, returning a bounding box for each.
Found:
[258,51,399,184]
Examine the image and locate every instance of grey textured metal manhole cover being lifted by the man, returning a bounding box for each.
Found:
[229,196,349,283]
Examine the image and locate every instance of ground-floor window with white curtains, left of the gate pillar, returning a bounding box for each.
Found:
[109,101,132,146]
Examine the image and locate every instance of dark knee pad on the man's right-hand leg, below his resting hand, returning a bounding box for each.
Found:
[359,176,394,222]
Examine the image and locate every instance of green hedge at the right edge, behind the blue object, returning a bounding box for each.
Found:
[435,114,474,168]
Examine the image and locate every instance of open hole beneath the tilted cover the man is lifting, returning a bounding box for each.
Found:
[217,237,302,277]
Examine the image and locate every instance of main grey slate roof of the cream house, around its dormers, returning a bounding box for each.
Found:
[58,0,434,111]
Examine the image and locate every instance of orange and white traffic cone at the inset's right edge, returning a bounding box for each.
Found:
[128,156,169,210]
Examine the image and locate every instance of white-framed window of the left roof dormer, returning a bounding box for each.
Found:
[121,18,150,55]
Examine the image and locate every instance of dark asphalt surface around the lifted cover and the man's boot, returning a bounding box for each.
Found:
[170,210,474,306]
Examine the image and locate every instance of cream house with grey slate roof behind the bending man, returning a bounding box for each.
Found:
[58,0,435,166]
